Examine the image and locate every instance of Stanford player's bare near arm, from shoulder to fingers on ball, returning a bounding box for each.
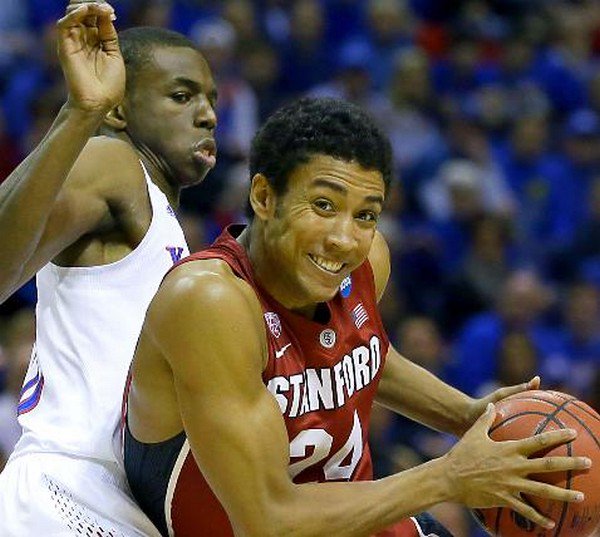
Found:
[144,262,582,537]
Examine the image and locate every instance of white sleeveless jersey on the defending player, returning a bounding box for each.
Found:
[11,162,189,461]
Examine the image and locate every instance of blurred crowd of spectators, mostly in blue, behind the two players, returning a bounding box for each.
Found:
[0,0,600,537]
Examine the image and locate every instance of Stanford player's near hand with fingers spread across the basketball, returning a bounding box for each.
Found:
[444,404,591,528]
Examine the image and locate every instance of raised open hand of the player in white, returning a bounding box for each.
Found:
[57,0,125,113]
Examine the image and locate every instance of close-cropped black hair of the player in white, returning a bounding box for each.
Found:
[119,26,200,91]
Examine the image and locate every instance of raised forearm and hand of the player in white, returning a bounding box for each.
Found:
[0,3,125,301]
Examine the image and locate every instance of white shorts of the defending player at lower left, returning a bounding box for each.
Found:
[0,453,160,537]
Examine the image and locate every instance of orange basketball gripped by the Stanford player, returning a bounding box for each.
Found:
[474,390,600,537]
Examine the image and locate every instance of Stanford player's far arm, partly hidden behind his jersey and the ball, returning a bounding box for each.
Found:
[369,233,539,435]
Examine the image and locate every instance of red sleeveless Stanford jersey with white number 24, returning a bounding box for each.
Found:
[124,228,426,537]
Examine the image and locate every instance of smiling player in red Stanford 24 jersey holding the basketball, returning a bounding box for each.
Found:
[124,99,589,537]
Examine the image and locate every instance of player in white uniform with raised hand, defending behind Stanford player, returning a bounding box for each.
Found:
[0,3,216,537]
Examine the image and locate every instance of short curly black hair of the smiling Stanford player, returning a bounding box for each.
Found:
[248,97,392,217]
